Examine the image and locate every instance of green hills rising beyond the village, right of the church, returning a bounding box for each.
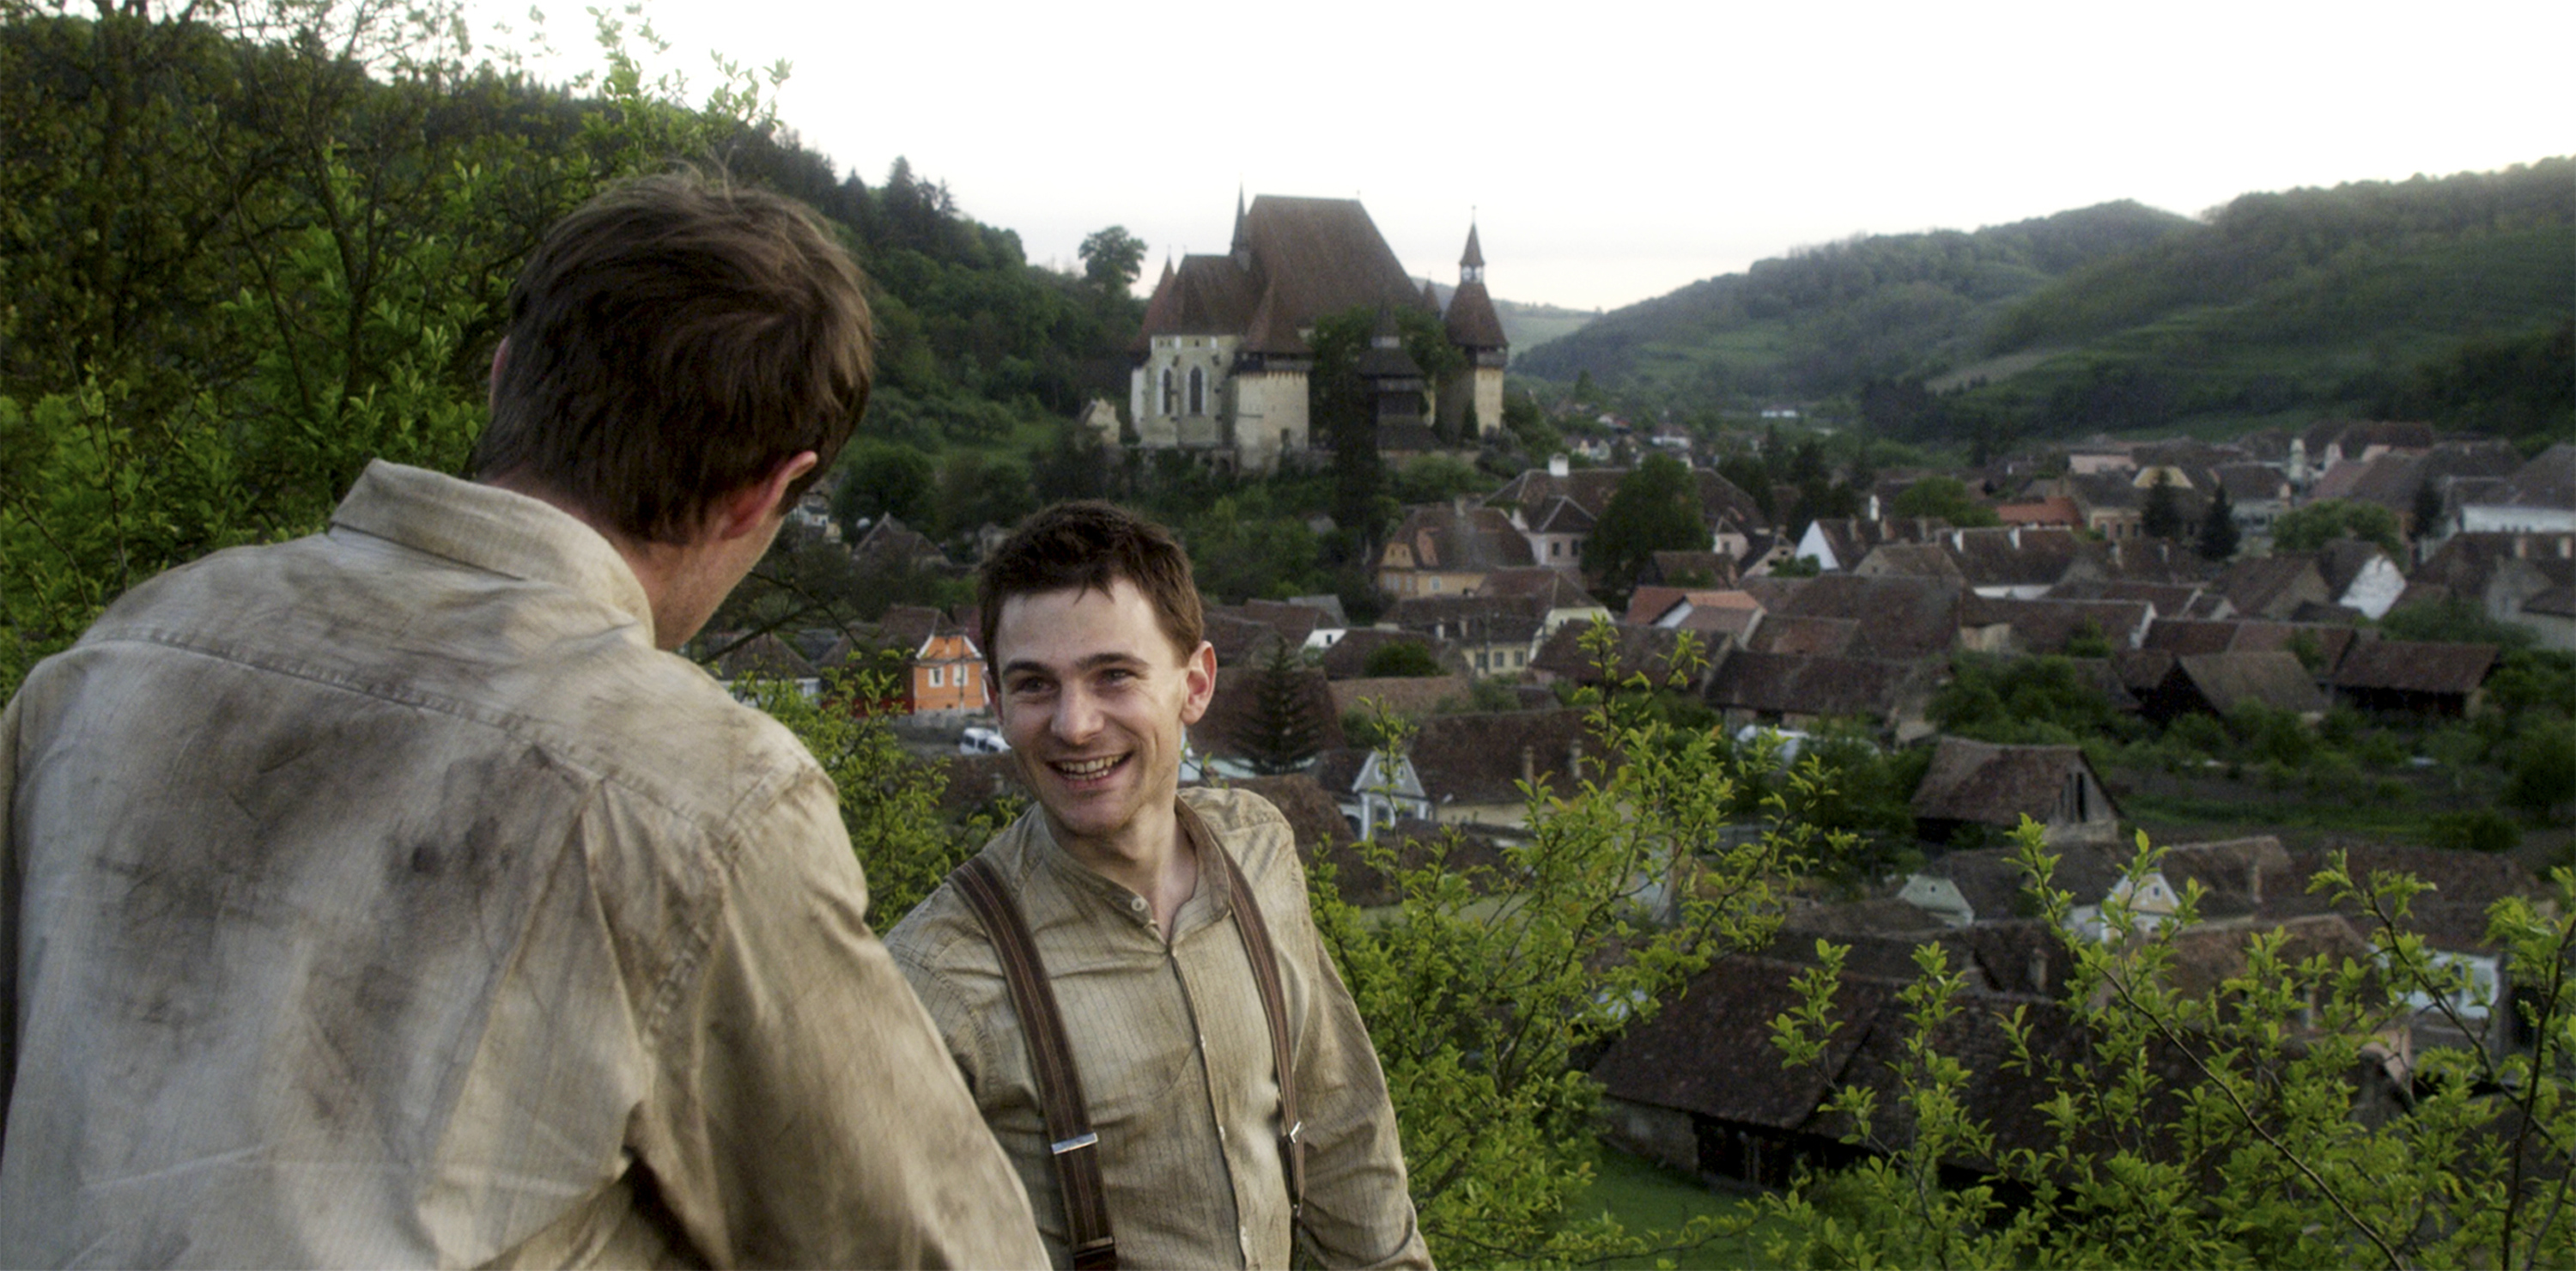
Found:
[1517,157,2576,435]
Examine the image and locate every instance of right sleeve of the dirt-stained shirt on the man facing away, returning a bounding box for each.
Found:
[636,774,1046,1268]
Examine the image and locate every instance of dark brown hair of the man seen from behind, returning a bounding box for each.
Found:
[474,173,871,541]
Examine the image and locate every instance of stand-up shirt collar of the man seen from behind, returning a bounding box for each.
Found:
[330,459,652,634]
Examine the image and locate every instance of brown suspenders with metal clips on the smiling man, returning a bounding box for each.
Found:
[948,805,1306,1271]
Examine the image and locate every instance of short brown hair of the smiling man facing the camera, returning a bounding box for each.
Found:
[976,500,1208,668]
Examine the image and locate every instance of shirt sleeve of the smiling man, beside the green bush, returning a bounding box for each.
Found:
[1273,825,1432,1268]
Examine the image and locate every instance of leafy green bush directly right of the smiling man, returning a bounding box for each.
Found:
[1311,623,1826,1266]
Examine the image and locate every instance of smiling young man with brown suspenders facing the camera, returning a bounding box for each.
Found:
[886,502,1430,1266]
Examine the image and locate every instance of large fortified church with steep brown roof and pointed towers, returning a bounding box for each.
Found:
[1128,193,1512,471]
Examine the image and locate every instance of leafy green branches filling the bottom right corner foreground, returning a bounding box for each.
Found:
[1765,818,2576,1268]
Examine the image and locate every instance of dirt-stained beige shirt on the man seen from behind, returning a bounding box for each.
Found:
[0,464,1043,1266]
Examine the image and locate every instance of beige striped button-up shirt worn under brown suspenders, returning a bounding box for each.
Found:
[886,789,1430,1268]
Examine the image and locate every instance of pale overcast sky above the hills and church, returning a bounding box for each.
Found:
[477,0,2576,309]
